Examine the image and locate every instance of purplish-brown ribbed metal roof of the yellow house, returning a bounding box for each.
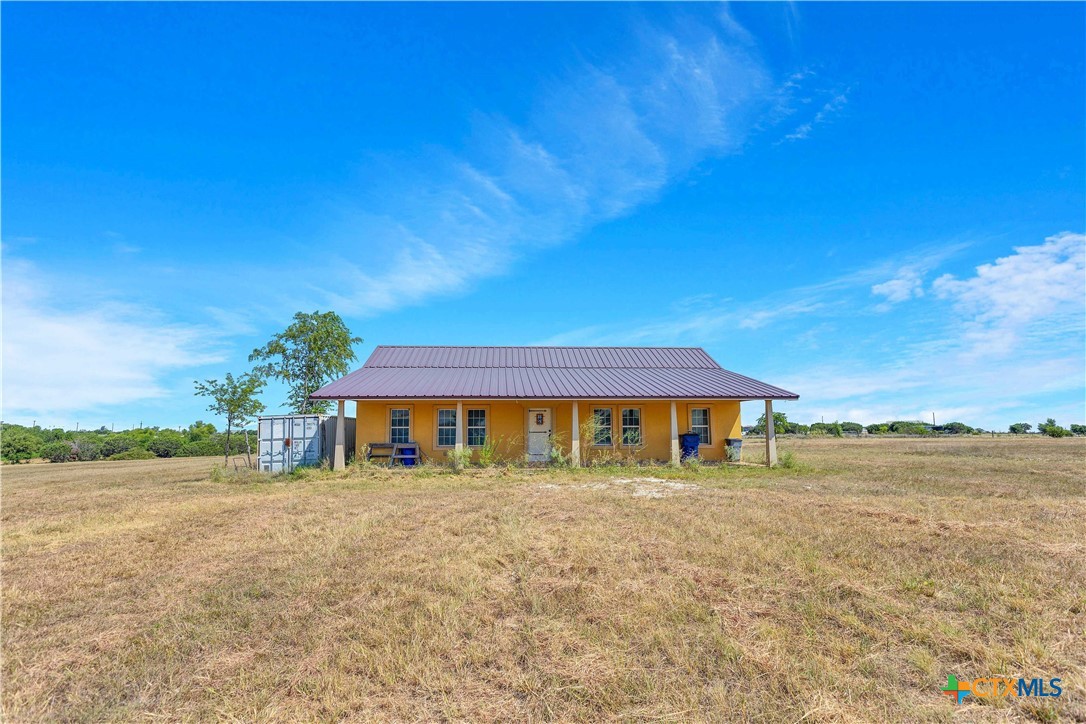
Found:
[312,346,799,399]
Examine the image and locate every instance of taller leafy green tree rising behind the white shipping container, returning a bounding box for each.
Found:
[249,312,362,412]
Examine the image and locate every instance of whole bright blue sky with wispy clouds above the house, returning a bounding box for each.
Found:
[2,3,1086,428]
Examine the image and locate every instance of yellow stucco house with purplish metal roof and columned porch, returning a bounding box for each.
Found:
[312,346,798,468]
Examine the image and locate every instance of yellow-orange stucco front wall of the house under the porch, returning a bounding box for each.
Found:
[355,399,742,461]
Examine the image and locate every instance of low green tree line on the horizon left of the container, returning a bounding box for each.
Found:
[0,420,256,462]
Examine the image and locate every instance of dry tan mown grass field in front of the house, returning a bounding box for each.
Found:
[0,436,1086,722]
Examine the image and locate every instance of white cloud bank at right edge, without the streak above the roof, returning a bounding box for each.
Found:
[781,232,1086,427]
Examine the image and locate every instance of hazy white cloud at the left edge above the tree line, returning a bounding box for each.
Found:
[2,258,222,422]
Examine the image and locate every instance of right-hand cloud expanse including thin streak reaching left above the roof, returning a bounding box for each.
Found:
[541,232,1086,427]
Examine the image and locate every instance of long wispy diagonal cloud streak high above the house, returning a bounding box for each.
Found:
[312,13,779,315]
